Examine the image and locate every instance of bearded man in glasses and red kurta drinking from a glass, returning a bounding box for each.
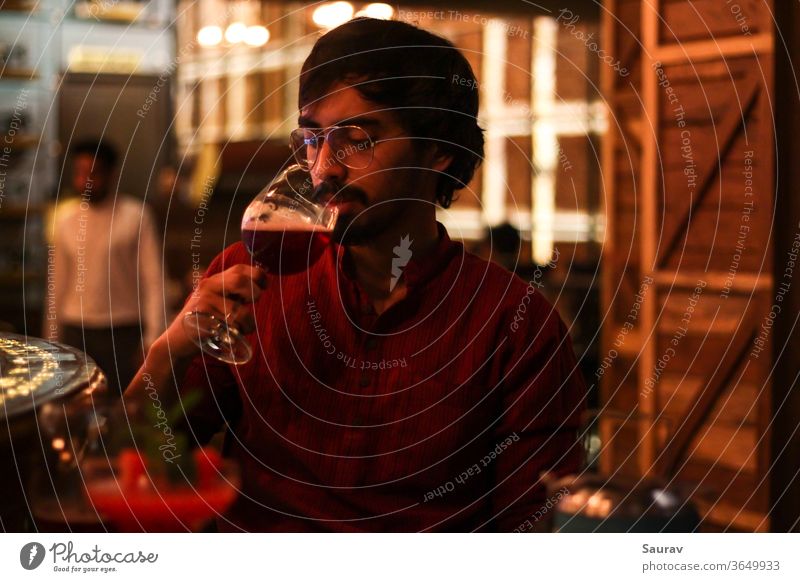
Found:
[130,19,585,531]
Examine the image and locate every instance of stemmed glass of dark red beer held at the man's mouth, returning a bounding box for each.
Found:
[183,164,338,365]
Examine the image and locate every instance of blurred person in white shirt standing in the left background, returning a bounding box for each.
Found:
[53,141,164,394]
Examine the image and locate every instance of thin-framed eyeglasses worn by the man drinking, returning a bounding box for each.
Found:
[289,125,383,170]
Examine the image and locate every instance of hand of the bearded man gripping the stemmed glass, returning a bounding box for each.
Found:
[157,265,267,357]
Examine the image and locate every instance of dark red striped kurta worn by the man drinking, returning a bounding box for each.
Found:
[182,225,586,531]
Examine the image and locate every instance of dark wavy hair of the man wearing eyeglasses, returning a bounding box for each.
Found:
[298,18,483,208]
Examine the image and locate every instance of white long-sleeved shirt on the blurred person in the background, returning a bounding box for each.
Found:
[53,194,164,346]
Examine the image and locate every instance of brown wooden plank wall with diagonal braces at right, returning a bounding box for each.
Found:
[598,0,787,531]
